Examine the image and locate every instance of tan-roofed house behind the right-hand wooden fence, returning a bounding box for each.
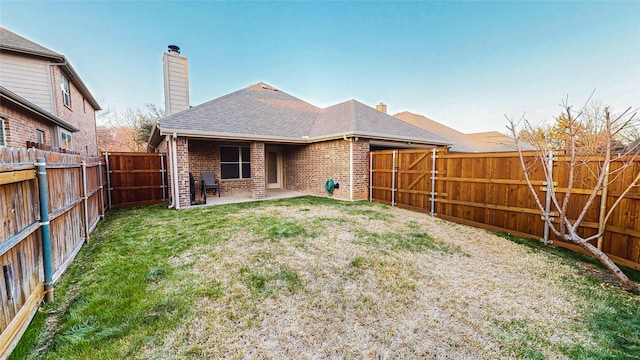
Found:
[393,111,535,152]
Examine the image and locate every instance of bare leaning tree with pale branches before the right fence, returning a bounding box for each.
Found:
[507,101,640,289]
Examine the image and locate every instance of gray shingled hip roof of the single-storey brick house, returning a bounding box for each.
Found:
[159,82,450,145]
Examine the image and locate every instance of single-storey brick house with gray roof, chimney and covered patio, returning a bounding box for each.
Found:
[149,46,449,208]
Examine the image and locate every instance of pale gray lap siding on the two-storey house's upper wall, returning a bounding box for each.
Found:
[0,53,55,113]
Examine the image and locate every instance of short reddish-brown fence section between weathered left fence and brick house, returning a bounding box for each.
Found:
[104,152,167,208]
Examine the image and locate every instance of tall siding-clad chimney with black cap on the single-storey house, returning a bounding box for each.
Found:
[162,45,189,116]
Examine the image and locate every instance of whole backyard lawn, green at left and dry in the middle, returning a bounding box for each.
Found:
[12,197,640,359]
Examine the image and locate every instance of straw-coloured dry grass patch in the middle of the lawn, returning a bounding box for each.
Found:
[149,206,589,359]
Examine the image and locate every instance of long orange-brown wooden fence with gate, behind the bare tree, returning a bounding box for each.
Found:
[369,149,640,269]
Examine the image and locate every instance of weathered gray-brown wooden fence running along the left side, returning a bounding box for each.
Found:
[0,147,106,358]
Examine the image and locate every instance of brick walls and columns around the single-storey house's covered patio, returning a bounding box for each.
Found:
[158,137,369,207]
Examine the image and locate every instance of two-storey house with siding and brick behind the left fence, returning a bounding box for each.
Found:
[0,27,100,155]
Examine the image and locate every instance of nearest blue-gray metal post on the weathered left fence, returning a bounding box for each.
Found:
[35,158,53,302]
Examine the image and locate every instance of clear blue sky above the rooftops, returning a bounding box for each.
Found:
[0,0,640,132]
